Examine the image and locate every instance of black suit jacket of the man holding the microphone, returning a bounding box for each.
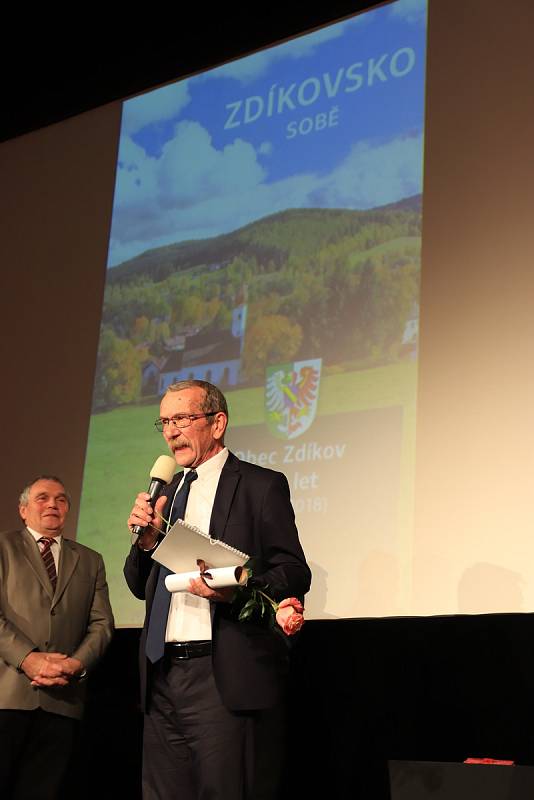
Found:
[124,453,311,711]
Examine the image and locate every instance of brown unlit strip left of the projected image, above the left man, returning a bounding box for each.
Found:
[0,104,120,535]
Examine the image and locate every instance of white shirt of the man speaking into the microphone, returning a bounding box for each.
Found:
[165,447,228,642]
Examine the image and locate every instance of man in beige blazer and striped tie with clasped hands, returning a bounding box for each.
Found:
[0,476,113,800]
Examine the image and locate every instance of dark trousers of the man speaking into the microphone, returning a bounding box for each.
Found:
[143,656,284,800]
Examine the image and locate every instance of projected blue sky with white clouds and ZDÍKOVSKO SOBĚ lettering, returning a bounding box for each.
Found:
[109,0,426,266]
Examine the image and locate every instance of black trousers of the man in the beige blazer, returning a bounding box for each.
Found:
[0,708,80,800]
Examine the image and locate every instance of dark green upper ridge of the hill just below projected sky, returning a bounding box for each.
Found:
[107,195,422,285]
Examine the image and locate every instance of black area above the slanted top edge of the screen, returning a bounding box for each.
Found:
[0,0,387,141]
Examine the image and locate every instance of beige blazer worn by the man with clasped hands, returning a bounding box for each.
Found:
[0,528,113,718]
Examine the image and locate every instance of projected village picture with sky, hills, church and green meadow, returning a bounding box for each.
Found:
[79,0,426,624]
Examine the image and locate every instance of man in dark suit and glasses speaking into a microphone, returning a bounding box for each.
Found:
[125,381,311,800]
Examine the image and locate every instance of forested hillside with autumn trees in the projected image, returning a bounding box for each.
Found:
[94,197,421,408]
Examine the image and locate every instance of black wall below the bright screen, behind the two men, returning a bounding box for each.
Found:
[76,615,534,800]
